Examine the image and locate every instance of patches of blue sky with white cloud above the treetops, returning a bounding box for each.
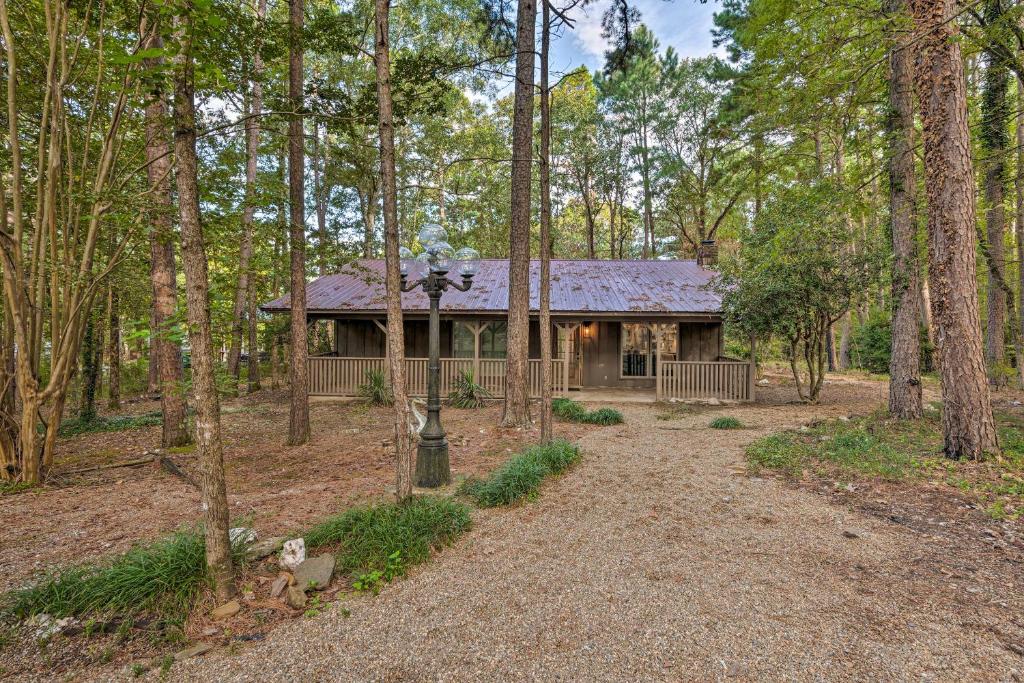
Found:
[551,0,720,73]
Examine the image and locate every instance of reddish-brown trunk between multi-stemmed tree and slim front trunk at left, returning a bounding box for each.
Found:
[145,31,191,449]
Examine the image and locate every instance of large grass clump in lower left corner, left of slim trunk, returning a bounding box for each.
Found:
[4,530,228,621]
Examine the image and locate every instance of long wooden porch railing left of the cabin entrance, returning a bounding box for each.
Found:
[309,355,567,398]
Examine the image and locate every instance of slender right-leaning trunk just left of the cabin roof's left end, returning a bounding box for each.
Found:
[227,0,266,382]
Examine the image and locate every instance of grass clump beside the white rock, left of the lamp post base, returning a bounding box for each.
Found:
[304,496,472,572]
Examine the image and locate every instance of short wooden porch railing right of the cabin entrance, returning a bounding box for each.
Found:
[656,360,754,400]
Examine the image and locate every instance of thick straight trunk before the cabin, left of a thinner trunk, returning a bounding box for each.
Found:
[502,0,537,427]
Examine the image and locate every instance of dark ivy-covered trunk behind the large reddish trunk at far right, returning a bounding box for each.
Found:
[979,0,1010,366]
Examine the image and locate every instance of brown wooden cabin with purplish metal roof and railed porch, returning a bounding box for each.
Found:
[261,259,754,400]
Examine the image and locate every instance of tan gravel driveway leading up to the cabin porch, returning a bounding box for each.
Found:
[163,393,1024,681]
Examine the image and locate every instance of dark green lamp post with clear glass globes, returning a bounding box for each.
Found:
[398,223,480,488]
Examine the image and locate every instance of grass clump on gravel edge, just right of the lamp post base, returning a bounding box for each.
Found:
[461,439,580,508]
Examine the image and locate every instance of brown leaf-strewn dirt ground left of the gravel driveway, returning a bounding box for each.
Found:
[0,392,587,592]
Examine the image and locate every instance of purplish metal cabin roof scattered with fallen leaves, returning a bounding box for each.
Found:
[261,259,722,315]
